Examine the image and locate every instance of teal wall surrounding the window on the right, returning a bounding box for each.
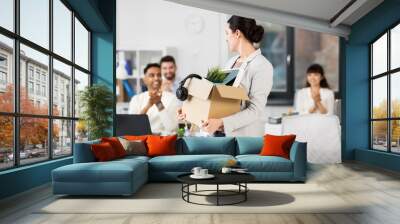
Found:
[342,0,400,170]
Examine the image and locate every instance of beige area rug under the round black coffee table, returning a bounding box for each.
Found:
[35,183,360,214]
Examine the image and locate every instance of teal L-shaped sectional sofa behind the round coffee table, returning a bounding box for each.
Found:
[52,137,307,195]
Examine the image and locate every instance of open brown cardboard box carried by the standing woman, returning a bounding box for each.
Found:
[182,78,249,127]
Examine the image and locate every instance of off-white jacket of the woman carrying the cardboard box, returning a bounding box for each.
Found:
[222,49,273,136]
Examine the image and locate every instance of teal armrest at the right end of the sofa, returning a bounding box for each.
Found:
[290,142,307,181]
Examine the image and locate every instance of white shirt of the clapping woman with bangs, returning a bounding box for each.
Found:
[295,87,335,115]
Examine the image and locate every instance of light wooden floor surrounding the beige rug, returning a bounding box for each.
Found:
[0,163,400,224]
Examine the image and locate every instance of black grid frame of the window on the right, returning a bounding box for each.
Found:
[368,20,400,155]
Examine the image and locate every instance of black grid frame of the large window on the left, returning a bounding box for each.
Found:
[0,0,93,172]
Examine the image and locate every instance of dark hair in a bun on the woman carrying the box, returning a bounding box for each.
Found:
[228,15,264,43]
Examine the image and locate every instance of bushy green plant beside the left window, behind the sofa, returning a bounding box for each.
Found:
[79,84,113,140]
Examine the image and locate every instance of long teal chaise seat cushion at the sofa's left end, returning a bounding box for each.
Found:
[52,159,147,182]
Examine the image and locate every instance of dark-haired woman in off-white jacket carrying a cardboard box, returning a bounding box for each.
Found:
[178,15,273,136]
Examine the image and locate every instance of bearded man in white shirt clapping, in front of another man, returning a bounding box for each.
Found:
[129,63,179,135]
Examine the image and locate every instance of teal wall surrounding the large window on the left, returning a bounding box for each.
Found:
[0,0,116,199]
